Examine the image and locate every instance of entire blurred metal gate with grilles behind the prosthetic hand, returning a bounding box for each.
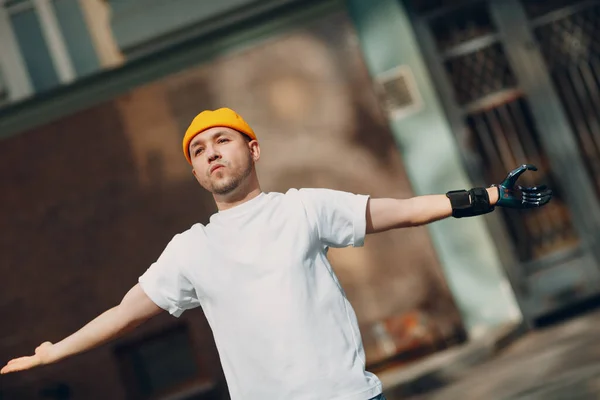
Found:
[405,0,600,322]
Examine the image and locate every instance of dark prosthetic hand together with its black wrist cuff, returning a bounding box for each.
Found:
[446,164,552,218]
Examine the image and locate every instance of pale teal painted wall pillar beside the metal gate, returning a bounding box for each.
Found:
[347,0,522,337]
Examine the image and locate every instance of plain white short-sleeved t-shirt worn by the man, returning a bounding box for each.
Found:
[139,189,382,400]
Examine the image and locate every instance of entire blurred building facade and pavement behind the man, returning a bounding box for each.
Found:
[0,0,600,400]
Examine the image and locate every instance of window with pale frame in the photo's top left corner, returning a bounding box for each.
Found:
[0,0,100,107]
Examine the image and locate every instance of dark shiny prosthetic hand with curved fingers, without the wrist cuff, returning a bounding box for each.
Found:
[494,164,552,209]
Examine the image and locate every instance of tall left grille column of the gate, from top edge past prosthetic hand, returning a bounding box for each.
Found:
[415,0,579,266]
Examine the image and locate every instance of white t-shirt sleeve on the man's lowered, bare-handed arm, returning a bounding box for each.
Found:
[139,235,200,317]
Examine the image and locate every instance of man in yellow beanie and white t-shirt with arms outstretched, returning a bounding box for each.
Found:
[0,108,551,400]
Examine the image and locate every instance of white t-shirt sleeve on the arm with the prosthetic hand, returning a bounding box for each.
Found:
[298,189,369,247]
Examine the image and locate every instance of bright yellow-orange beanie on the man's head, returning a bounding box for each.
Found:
[183,108,256,164]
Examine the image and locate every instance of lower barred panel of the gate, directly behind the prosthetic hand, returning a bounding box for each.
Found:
[467,97,579,261]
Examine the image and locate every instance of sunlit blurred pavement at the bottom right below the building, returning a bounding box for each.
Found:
[378,308,600,400]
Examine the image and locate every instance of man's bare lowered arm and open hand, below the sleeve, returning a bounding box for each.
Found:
[0,284,163,374]
